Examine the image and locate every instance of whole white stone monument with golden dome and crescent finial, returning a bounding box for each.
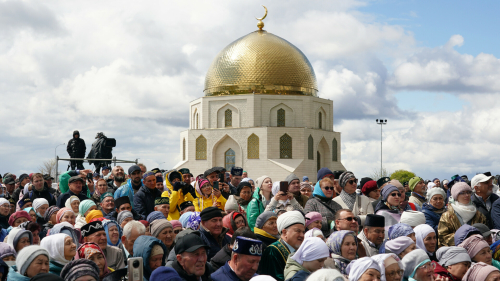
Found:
[175,9,345,182]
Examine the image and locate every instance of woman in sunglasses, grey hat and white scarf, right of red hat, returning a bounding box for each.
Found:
[376,184,401,234]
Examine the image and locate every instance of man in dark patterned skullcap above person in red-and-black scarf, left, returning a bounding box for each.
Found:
[81,221,125,270]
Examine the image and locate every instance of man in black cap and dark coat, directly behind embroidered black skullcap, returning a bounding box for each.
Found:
[200,207,231,261]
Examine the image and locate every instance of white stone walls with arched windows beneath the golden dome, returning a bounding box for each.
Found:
[175,94,345,181]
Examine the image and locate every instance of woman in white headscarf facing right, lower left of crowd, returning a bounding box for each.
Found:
[40,233,76,275]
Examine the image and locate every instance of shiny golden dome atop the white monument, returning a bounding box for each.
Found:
[203,30,318,97]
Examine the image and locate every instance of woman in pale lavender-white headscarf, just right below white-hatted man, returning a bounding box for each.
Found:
[285,237,330,281]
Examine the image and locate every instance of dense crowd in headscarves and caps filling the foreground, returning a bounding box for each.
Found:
[0,164,500,281]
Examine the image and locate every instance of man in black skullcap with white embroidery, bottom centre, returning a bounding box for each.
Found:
[211,236,263,281]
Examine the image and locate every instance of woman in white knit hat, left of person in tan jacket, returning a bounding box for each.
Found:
[422,188,446,233]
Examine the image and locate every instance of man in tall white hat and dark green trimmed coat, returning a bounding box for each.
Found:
[259,211,306,281]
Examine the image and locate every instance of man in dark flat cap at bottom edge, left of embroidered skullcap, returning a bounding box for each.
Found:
[172,233,211,281]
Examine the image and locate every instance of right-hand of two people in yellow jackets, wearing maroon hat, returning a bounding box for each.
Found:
[193,178,226,212]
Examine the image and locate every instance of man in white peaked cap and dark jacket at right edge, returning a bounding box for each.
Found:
[471,174,498,229]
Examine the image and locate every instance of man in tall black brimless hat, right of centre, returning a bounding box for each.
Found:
[358,214,385,257]
